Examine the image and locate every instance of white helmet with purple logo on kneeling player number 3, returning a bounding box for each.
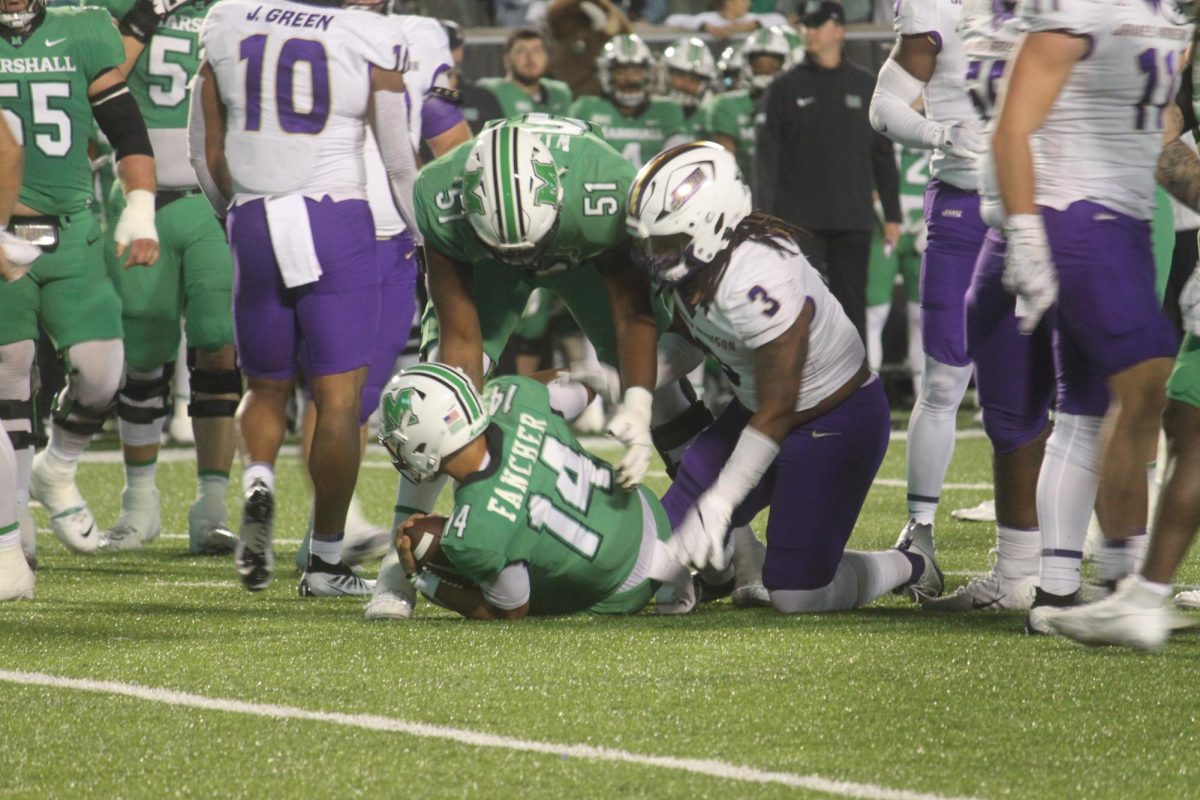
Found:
[625,142,751,288]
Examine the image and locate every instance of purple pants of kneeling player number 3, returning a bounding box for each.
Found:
[662,379,892,590]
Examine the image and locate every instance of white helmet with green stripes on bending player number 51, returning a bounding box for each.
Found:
[460,121,563,267]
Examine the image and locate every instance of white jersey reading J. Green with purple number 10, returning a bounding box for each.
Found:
[200,0,406,200]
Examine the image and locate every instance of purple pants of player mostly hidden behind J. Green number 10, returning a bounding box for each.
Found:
[359,230,418,422]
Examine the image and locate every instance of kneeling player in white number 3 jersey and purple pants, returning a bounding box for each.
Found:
[628,143,943,613]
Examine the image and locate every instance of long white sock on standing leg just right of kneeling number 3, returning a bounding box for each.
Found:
[907,356,971,525]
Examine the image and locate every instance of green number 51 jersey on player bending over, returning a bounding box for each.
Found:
[413,113,636,272]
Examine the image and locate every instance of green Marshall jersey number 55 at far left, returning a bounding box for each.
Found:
[0,7,125,215]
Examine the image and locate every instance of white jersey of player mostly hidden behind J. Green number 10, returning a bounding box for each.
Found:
[365,16,454,239]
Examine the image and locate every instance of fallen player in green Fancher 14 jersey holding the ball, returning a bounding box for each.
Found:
[379,363,695,619]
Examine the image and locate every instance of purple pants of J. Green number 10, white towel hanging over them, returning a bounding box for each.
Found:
[227,198,379,380]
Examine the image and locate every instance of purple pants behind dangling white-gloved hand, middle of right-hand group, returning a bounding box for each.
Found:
[966,230,1055,453]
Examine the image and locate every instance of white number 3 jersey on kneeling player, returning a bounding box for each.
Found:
[676,241,866,411]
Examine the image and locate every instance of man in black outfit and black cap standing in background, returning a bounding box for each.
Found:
[755,0,901,336]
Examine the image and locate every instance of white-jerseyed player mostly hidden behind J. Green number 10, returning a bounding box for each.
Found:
[296,6,470,571]
